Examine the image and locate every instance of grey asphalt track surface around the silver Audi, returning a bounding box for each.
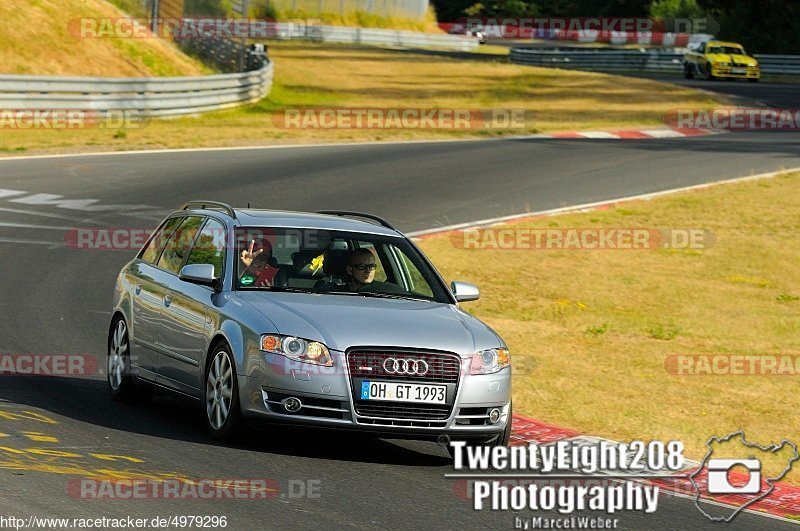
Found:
[0,78,800,529]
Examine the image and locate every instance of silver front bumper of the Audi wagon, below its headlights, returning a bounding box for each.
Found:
[238,351,511,440]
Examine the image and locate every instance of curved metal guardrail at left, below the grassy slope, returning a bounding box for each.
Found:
[0,62,273,117]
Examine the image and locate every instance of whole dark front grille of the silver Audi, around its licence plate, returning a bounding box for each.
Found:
[347,350,461,427]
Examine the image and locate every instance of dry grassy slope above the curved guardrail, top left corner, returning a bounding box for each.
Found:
[0,0,208,77]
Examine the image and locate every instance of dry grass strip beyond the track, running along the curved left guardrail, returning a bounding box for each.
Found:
[0,42,718,153]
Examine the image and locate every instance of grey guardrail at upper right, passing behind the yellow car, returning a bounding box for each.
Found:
[510,48,800,75]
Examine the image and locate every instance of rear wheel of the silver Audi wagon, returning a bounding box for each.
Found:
[106,315,153,403]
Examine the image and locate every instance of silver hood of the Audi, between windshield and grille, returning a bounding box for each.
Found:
[234,291,505,356]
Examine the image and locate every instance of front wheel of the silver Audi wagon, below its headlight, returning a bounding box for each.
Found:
[203,342,244,442]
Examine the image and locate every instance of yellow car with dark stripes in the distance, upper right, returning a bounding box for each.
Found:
[683,41,761,82]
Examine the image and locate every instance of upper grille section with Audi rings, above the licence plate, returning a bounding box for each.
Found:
[347,351,461,384]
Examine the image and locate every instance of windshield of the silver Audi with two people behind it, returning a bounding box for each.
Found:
[236,227,452,303]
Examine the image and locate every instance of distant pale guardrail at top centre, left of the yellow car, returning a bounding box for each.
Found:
[267,22,480,51]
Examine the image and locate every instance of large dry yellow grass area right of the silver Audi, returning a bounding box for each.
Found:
[421,173,800,484]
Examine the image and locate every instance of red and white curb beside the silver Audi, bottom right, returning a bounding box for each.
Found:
[494,415,800,523]
